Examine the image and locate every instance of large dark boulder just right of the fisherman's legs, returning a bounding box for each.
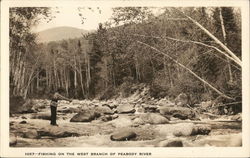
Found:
[70,110,100,122]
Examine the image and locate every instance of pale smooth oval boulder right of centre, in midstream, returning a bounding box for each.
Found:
[140,113,169,124]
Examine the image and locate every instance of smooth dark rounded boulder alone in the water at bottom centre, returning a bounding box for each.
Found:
[110,129,136,141]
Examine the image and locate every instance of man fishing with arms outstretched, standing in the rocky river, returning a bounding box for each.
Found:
[50,88,72,126]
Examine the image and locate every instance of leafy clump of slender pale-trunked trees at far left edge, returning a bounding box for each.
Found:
[9,7,50,97]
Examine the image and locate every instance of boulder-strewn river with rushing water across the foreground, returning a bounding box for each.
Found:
[10,99,242,147]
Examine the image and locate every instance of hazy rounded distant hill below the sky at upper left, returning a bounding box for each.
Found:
[37,27,89,43]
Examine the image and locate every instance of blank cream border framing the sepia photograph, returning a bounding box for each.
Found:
[0,0,250,157]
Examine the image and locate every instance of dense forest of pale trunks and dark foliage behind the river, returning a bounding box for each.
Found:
[10,7,242,107]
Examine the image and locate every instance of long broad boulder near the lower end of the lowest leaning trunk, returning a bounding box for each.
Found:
[159,106,195,120]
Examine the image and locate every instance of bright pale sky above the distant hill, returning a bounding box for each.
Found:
[33,7,112,32]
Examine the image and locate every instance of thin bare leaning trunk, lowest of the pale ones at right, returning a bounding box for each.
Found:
[137,41,233,99]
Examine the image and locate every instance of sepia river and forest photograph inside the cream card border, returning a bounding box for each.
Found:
[1,2,249,157]
